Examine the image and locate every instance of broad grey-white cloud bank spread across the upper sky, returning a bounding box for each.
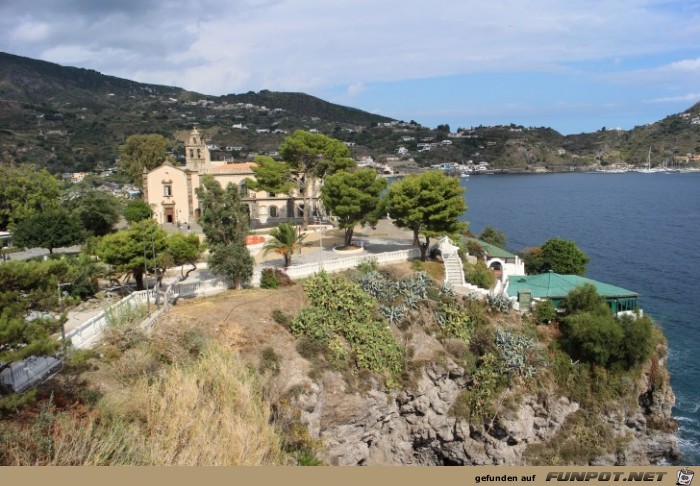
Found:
[0,0,698,96]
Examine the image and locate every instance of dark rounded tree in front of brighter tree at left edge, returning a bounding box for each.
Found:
[12,209,85,253]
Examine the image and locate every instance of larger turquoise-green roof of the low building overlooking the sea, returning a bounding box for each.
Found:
[507,272,638,299]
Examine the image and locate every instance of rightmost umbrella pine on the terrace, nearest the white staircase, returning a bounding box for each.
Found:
[387,170,468,260]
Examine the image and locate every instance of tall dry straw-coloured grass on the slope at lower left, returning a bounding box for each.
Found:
[0,322,286,465]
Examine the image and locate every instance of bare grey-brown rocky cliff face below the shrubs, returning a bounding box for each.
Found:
[282,332,679,465]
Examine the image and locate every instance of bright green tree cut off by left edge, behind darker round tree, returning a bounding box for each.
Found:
[0,165,60,231]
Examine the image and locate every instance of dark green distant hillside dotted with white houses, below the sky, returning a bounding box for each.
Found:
[0,53,700,173]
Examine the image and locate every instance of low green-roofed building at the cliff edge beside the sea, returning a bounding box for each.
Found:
[506,271,639,314]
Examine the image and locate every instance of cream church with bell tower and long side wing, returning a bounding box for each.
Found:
[143,129,320,226]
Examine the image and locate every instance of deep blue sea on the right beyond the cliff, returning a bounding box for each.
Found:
[461,172,700,464]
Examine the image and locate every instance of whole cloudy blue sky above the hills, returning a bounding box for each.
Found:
[0,0,700,134]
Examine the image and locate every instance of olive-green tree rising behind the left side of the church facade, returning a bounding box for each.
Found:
[117,134,168,187]
